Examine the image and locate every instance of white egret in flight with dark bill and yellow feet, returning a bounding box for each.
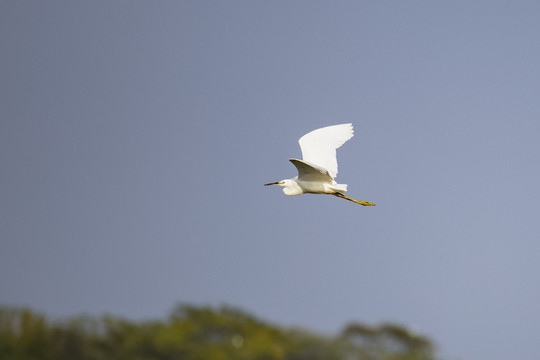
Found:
[264,124,375,206]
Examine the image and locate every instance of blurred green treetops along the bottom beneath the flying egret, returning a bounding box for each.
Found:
[0,305,435,360]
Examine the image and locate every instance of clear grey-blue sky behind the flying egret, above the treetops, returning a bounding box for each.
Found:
[0,1,540,360]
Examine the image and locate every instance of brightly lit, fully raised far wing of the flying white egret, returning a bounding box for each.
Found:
[295,124,354,178]
